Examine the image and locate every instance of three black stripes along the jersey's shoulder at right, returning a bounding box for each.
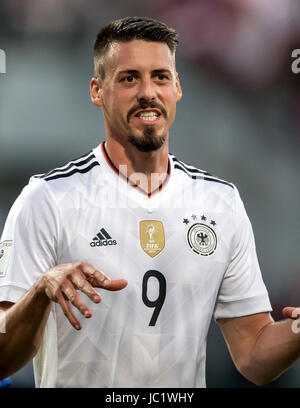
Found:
[170,154,236,192]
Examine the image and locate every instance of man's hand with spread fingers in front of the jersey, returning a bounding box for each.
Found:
[36,262,127,330]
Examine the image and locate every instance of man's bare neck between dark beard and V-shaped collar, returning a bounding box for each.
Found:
[105,137,169,194]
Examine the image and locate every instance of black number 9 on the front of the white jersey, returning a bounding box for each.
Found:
[142,271,167,326]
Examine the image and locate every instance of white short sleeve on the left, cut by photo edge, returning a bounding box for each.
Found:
[0,179,59,303]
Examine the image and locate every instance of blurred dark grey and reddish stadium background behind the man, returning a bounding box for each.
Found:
[0,0,300,387]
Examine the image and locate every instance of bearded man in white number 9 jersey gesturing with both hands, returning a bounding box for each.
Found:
[0,17,300,387]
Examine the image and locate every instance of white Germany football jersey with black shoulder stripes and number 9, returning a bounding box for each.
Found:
[0,143,272,388]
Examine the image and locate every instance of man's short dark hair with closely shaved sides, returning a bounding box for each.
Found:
[94,17,178,78]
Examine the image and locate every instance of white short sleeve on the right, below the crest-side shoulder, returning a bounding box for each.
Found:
[214,188,272,319]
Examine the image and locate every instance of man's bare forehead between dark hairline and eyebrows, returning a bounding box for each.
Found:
[105,40,175,74]
